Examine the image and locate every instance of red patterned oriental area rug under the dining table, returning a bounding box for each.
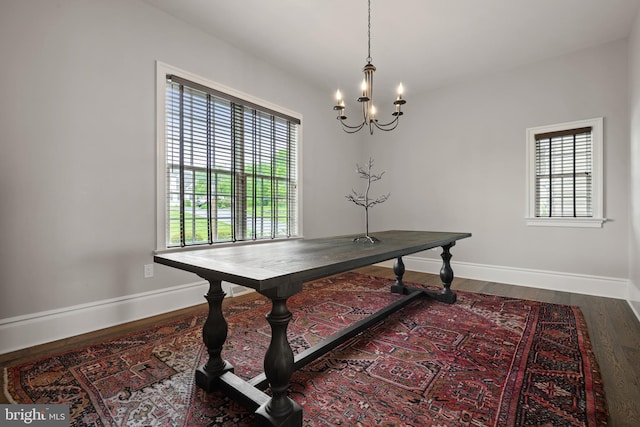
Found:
[5,273,607,427]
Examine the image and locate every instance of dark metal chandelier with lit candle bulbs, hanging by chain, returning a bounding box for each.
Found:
[333,0,407,135]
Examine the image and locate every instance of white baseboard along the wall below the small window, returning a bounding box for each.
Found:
[379,256,629,300]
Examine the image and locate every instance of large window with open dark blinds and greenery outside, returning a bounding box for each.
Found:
[158,64,300,249]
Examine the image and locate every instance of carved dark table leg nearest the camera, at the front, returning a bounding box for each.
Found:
[255,297,302,426]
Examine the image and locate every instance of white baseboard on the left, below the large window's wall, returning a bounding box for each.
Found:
[0,281,209,354]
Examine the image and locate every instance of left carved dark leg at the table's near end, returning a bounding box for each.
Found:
[196,280,233,392]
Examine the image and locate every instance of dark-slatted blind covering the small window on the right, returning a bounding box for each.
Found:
[535,127,593,218]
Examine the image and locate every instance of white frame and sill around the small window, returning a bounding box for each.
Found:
[525,117,606,228]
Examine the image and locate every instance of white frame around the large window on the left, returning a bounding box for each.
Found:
[156,61,303,252]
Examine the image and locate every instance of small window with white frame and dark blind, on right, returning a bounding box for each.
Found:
[527,118,605,227]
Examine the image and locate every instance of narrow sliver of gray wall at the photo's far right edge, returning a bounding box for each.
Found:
[629,7,640,317]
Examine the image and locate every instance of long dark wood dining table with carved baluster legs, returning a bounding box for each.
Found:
[154,230,471,426]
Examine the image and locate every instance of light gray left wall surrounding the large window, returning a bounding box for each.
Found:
[0,0,360,344]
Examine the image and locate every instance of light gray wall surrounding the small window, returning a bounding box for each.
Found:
[372,41,629,295]
